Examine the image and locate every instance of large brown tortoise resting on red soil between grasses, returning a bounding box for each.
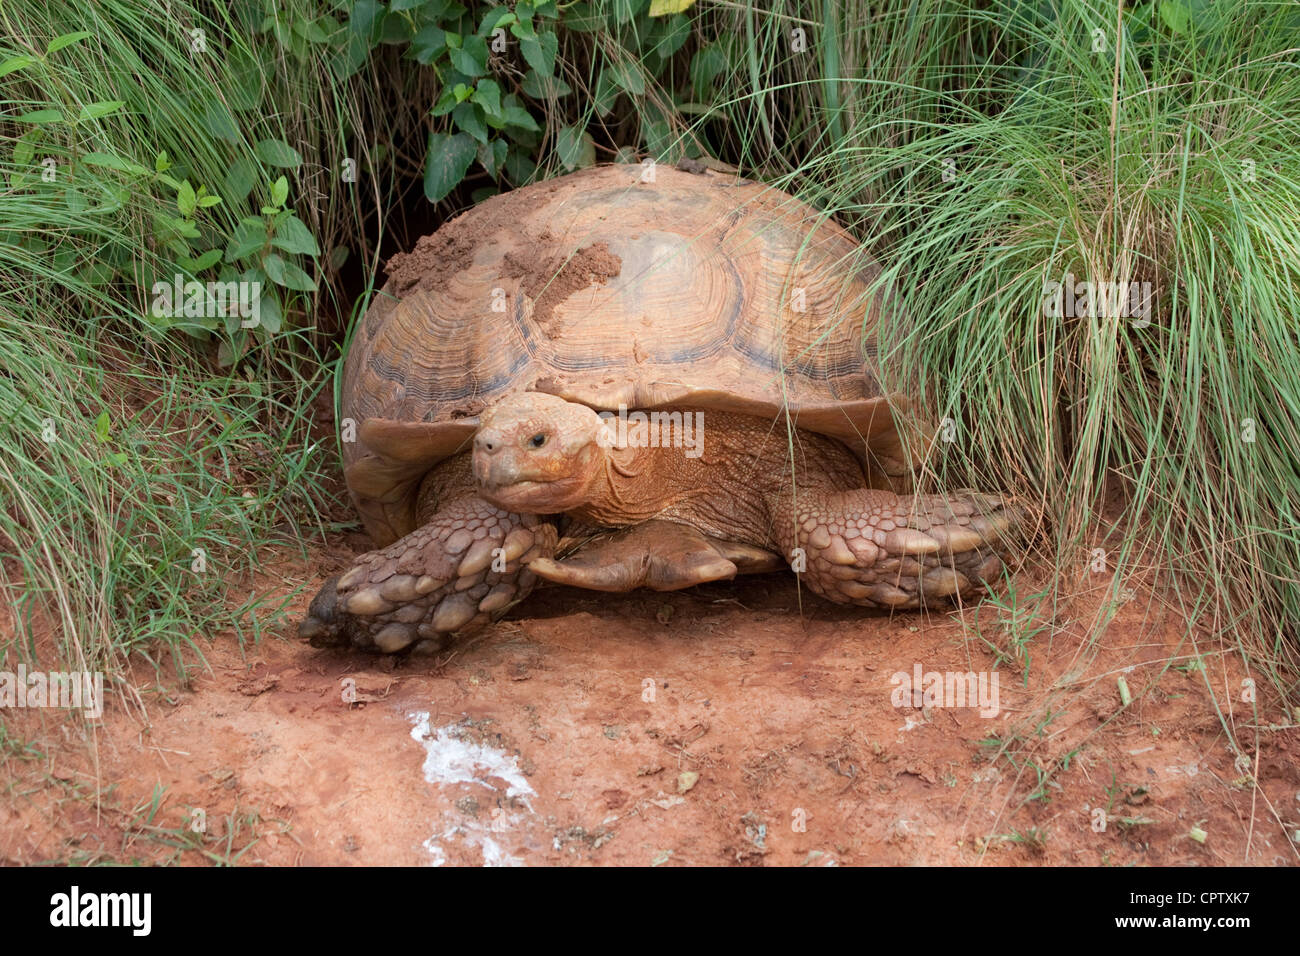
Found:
[299,164,1023,653]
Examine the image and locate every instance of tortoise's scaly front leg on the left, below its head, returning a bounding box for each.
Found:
[298,496,556,654]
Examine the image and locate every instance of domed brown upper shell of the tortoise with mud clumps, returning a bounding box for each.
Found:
[342,165,905,546]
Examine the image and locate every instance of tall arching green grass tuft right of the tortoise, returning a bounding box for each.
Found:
[693,0,1300,689]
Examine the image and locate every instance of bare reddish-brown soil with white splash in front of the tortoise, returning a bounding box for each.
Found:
[0,535,1300,866]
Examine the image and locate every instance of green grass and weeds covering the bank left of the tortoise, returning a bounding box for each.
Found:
[0,0,377,695]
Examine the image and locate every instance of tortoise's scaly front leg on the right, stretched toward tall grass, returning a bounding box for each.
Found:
[770,489,1024,607]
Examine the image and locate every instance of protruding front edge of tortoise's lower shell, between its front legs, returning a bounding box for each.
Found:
[529,520,781,592]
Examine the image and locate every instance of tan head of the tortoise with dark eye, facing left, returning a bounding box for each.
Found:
[473,392,608,514]
